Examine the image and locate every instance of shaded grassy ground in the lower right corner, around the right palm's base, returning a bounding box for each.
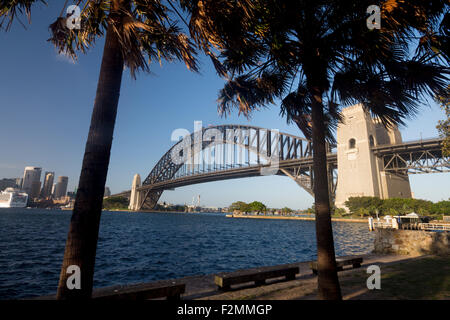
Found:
[202,255,450,300]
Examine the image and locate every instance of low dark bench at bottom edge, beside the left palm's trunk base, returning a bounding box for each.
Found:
[32,280,186,300]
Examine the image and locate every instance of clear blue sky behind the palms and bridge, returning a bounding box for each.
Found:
[0,2,450,209]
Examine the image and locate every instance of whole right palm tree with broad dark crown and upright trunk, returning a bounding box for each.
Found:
[181,0,449,299]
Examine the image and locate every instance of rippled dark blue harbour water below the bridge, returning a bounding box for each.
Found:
[0,208,374,300]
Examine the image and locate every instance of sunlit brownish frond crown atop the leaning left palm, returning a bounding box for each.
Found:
[49,0,198,77]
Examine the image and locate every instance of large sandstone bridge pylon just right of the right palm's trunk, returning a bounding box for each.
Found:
[335,104,411,208]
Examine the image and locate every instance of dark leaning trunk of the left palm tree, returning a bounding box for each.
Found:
[57,15,124,299]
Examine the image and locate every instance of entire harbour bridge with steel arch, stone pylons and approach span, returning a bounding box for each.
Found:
[113,106,450,210]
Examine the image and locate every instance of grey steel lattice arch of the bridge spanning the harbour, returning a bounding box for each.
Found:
[138,124,337,209]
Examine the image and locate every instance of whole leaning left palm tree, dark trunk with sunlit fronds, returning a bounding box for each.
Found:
[0,0,197,299]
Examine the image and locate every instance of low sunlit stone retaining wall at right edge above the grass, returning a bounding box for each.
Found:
[374,229,450,255]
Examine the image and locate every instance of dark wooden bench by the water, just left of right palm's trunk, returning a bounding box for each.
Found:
[214,266,299,291]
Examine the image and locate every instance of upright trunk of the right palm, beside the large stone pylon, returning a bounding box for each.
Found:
[311,91,342,300]
